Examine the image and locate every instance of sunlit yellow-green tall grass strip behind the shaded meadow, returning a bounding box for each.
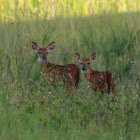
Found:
[0,0,140,21]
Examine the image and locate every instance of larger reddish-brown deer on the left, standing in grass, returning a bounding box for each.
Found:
[32,42,80,92]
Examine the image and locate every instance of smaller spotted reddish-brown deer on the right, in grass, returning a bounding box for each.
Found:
[75,53,115,97]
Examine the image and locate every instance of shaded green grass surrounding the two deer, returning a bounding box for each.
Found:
[0,13,140,140]
